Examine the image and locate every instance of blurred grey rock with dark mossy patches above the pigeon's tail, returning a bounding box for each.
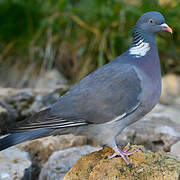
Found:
[0,85,68,134]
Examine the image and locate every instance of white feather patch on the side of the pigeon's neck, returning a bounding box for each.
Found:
[129,39,150,58]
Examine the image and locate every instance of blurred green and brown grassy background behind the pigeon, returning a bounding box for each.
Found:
[0,0,180,86]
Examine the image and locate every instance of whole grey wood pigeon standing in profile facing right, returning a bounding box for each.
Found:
[0,11,172,165]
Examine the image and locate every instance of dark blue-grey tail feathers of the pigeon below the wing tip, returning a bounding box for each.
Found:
[0,129,53,151]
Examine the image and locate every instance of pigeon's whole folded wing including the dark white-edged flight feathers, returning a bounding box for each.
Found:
[10,62,142,131]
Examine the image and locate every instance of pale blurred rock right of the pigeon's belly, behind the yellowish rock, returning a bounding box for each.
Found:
[118,105,180,151]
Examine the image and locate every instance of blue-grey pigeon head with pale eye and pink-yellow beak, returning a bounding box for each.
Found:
[135,11,172,34]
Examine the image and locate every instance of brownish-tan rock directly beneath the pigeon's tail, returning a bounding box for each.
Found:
[17,134,87,166]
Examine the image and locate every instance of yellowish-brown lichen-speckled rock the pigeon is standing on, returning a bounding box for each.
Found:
[63,146,180,180]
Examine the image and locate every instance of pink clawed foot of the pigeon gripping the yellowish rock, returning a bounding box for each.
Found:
[108,144,139,165]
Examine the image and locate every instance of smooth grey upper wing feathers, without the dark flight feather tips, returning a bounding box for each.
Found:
[50,63,142,123]
